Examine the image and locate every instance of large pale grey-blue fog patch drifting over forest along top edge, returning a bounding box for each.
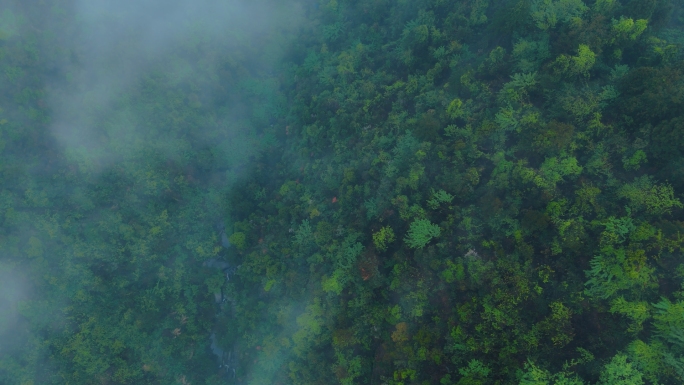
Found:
[47,0,301,173]
